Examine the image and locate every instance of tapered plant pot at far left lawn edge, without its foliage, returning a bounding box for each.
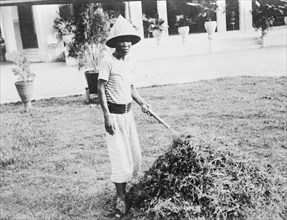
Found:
[15,81,34,110]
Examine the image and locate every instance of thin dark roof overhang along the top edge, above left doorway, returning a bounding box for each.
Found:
[0,0,146,6]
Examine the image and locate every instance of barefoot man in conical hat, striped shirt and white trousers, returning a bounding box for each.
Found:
[98,16,150,213]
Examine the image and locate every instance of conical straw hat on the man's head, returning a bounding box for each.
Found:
[106,15,141,48]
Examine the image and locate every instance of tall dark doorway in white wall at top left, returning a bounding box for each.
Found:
[18,4,38,49]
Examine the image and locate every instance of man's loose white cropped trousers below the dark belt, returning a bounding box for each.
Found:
[106,111,142,183]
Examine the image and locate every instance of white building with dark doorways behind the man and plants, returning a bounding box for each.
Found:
[0,0,252,62]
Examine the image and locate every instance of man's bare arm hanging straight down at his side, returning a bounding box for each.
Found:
[98,79,115,135]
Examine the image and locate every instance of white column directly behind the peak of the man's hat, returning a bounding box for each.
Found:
[125,1,144,38]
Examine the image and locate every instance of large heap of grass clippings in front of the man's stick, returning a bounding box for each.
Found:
[130,135,287,220]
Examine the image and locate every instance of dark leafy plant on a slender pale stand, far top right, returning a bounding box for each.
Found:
[252,1,283,46]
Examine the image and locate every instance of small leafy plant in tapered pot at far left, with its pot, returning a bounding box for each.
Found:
[12,55,35,111]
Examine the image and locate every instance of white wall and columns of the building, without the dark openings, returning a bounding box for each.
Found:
[0,0,252,62]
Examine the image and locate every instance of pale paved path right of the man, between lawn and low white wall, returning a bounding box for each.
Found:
[137,46,286,86]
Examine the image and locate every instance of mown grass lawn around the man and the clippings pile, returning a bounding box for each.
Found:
[0,77,287,220]
